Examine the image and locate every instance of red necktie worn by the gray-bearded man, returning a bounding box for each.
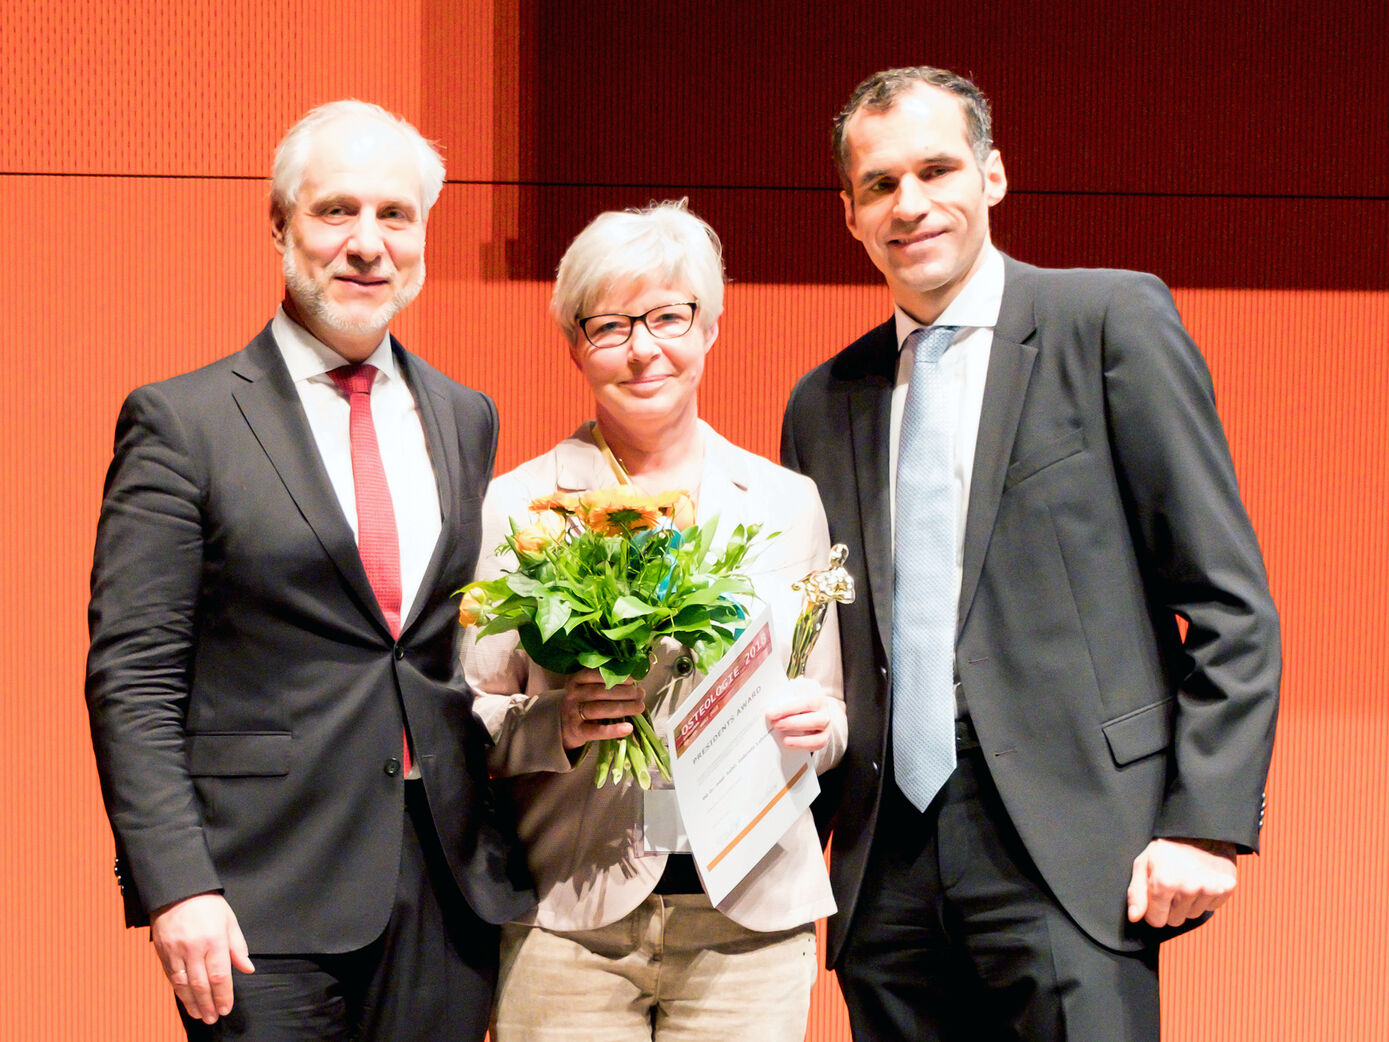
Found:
[328,364,410,774]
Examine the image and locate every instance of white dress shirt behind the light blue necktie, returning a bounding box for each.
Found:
[888,243,1003,599]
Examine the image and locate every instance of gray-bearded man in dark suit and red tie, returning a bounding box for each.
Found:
[86,101,533,1039]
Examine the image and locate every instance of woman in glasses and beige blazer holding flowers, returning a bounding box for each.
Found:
[465,201,847,1042]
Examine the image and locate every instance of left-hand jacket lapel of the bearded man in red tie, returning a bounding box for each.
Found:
[232,325,389,634]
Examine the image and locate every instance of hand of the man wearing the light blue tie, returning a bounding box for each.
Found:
[1128,839,1236,927]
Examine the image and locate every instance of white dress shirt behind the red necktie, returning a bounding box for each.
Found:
[271,307,443,625]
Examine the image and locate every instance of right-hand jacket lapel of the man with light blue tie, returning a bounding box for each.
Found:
[960,258,1036,629]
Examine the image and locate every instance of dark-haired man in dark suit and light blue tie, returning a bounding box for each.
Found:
[782,67,1281,1042]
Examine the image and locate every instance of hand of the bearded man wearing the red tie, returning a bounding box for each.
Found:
[150,893,256,1024]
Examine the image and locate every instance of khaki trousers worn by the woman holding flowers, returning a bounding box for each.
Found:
[492,893,818,1042]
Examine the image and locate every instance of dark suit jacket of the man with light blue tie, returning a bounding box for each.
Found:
[782,258,1281,960]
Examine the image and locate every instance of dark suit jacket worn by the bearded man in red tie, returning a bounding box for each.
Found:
[86,326,533,953]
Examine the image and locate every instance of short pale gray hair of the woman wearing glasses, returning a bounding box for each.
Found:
[550,199,724,343]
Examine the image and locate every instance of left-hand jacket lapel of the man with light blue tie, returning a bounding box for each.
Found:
[836,320,897,659]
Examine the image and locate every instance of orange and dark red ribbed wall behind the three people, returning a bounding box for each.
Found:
[0,0,1389,1042]
